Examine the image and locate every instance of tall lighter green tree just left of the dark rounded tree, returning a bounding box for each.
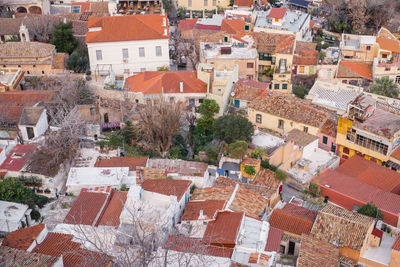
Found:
[197,99,219,135]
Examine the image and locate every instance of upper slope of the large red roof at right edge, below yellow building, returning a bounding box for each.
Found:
[335,155,400,194]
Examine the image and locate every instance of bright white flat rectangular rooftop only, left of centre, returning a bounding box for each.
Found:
[66,167,129,186]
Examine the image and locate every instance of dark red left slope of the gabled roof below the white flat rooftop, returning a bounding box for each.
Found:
[64,190,108,225]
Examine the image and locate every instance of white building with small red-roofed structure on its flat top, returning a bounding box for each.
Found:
[254,8,312,42]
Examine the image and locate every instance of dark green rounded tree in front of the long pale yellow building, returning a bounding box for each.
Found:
[214,115,254,144]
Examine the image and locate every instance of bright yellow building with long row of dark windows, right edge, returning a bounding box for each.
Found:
[336,94,400,166]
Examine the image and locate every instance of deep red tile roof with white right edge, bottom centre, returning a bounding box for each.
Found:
[203,211,244,247]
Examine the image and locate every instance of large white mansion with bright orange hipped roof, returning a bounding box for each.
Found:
[86,14,169,75]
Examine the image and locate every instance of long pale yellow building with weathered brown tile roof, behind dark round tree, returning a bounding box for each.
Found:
[248,92,331,136]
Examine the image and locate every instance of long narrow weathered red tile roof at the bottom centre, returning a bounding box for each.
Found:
[163,235,233,258]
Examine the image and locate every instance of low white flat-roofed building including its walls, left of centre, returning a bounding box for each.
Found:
[66,167,136,195]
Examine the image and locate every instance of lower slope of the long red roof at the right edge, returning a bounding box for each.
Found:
[319,170,400,215]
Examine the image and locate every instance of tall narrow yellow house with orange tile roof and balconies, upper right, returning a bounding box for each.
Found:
[251,32,296,93]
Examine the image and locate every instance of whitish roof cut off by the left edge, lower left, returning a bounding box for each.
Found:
[0,201,29,232]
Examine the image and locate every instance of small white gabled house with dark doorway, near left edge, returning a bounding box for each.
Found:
[18,107,49,141]
